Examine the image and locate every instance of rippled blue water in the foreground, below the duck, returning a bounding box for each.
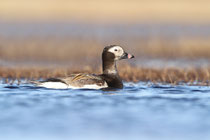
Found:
[0,82,210,140]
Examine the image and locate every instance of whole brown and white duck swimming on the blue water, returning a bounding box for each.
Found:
[33,45,134,89]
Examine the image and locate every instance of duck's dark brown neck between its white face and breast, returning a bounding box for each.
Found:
[103,60,118,75]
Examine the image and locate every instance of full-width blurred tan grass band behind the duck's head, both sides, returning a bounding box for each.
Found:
[0,37,210,61]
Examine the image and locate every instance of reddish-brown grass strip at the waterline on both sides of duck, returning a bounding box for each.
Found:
[0,65,210,86]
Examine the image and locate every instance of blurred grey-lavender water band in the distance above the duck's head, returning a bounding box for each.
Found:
[0,20,210,38]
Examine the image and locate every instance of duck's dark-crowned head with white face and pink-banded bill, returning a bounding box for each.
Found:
[102,45,134,61]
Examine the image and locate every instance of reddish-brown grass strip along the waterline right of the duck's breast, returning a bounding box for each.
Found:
[120,66,210,85]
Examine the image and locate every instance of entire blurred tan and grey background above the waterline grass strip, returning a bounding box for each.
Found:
[0,0,210,81]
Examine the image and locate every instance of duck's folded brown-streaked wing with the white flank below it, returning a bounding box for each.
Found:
[61,73,108,89]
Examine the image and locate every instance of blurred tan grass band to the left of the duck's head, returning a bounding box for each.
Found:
[0,38,102,62]
